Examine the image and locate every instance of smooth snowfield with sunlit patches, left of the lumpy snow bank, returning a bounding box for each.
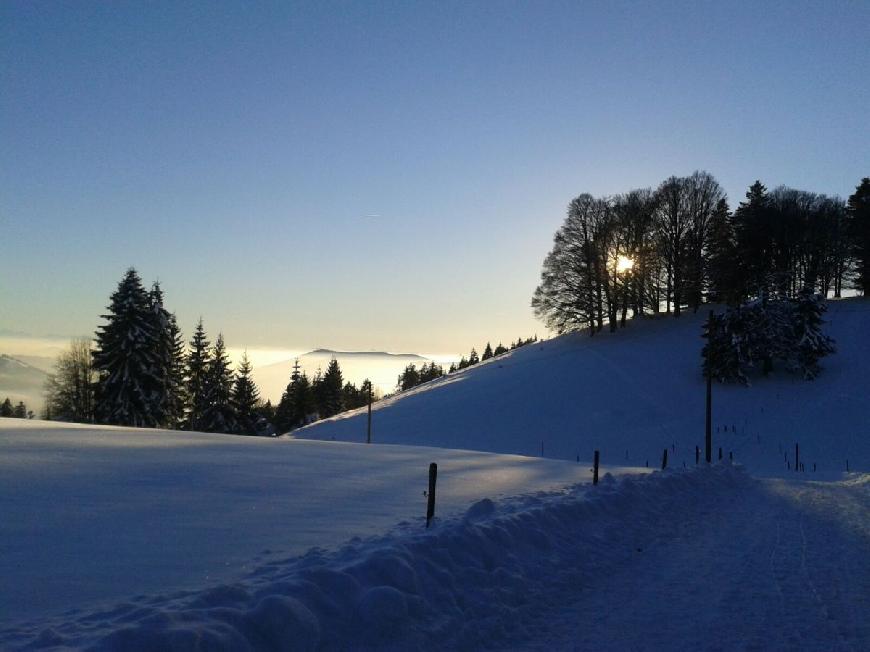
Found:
[0,419,632,628]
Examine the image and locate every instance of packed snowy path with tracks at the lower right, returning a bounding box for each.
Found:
[526,480,870,651]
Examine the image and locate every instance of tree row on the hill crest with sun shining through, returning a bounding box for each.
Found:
[532,172,870,335]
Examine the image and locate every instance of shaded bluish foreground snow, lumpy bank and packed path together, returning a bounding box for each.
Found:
[0,463,870,651]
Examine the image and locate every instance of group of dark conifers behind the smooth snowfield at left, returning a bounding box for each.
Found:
[43,268,375,435]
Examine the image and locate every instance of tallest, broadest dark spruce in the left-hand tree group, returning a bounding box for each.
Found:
[93,267,161,427]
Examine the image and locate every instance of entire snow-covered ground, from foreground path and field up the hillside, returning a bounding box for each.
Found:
[0,300,870,651]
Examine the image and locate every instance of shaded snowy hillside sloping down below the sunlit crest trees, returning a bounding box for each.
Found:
[293,299,870,477]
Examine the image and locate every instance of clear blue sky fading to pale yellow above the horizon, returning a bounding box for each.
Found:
[0,1,870,352]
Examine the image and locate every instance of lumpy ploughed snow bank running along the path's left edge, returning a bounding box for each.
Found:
[0,465,754,652]
